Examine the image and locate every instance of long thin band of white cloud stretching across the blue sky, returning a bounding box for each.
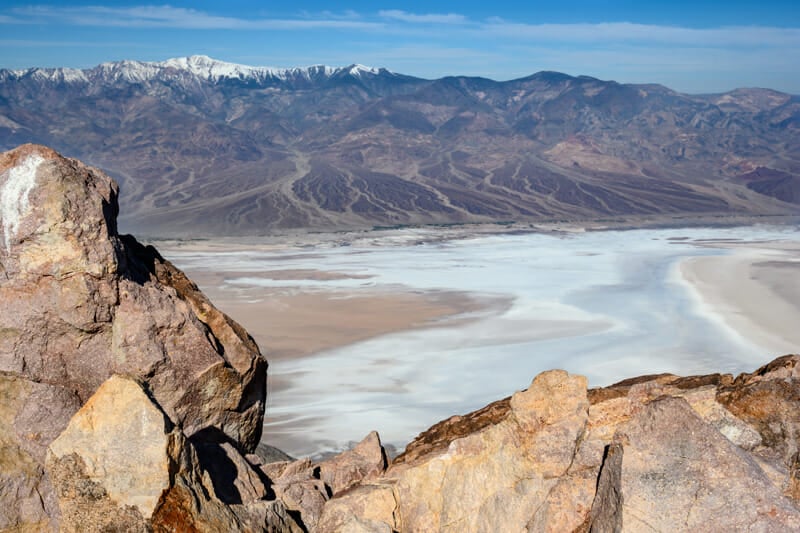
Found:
[7,5,800,48]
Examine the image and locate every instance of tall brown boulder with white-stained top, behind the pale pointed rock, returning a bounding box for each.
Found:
[0,145,267,529]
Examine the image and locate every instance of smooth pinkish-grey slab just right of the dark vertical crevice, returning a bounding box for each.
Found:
[617,398,800,531]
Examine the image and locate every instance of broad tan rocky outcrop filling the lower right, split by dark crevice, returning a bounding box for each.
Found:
[317,356,800,532]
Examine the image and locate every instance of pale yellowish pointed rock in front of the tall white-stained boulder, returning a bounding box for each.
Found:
[47,376,177,531]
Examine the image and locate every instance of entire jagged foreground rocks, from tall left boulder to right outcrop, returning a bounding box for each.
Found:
[0,145,800,532]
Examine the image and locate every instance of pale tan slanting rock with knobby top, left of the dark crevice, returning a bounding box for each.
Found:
[328,371,589,531]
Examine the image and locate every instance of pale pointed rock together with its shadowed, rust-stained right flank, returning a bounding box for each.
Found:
[47,376,301,532]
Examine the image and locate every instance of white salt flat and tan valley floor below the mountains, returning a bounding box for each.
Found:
[156,225,800,456]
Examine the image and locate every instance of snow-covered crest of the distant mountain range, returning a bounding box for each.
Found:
[0,55,397,84]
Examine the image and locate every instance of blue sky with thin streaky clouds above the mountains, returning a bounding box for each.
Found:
[0,0,800,94]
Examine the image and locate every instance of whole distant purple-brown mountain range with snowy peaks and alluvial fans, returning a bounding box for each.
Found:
[0,56,800,236]
